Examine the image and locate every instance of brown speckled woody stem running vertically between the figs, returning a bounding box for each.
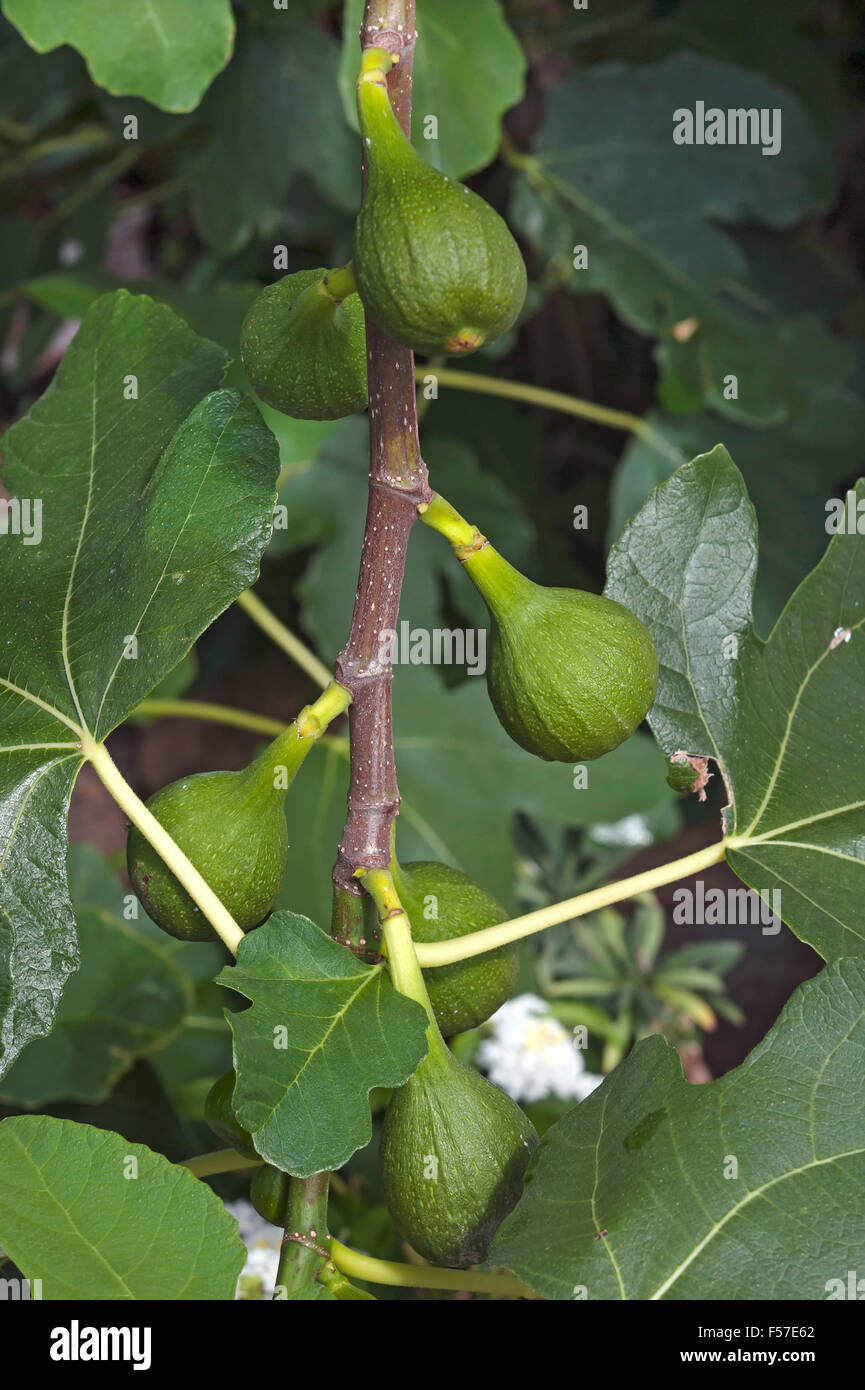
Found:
[334,0,431,897]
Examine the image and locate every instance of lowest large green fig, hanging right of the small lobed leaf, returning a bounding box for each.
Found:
[381,1040,538,1269]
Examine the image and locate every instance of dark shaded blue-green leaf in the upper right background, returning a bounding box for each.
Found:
[513,53,846,424]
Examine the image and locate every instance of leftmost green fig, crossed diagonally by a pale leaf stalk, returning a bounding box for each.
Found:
[127,745,288,941]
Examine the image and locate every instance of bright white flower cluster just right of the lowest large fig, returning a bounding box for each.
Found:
[476,994,604,1101]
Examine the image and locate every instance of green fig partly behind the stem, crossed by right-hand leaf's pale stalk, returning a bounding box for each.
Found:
[391,859,519,1038]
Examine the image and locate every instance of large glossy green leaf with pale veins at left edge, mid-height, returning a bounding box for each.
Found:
[0,291,278,1068]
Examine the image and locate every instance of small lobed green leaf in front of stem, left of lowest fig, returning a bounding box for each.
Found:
[217,912,427,1177]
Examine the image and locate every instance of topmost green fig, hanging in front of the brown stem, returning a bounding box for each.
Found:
[353,60,526,354]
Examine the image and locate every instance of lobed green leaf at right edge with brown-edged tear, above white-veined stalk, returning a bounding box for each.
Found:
[605,445,865,959]
